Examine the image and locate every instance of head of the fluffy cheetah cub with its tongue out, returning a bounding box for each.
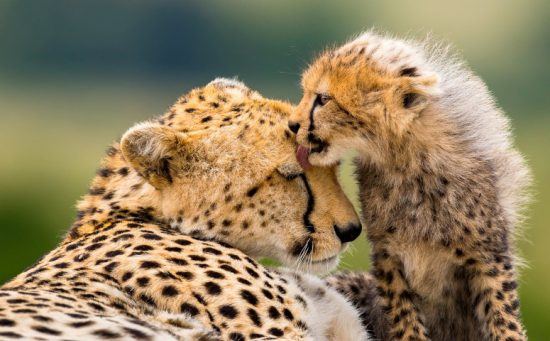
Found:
[289,32,439,166]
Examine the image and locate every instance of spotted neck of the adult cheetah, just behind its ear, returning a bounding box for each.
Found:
[67,144,162,239]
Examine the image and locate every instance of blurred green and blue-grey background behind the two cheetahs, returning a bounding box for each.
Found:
[0,0,550,340]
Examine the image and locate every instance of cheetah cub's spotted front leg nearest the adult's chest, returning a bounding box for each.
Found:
[372,244,429,341]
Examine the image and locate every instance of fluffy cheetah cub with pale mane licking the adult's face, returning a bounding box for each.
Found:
[290,32,530,341]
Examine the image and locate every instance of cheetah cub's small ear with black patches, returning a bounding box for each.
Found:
[399,67,441,116]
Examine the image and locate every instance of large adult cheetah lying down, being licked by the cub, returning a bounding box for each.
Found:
[0,79,367,340]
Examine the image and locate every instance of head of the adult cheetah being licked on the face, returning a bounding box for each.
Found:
[121,79,361,272]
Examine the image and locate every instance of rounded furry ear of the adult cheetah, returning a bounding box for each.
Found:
[120,122,201,189]
